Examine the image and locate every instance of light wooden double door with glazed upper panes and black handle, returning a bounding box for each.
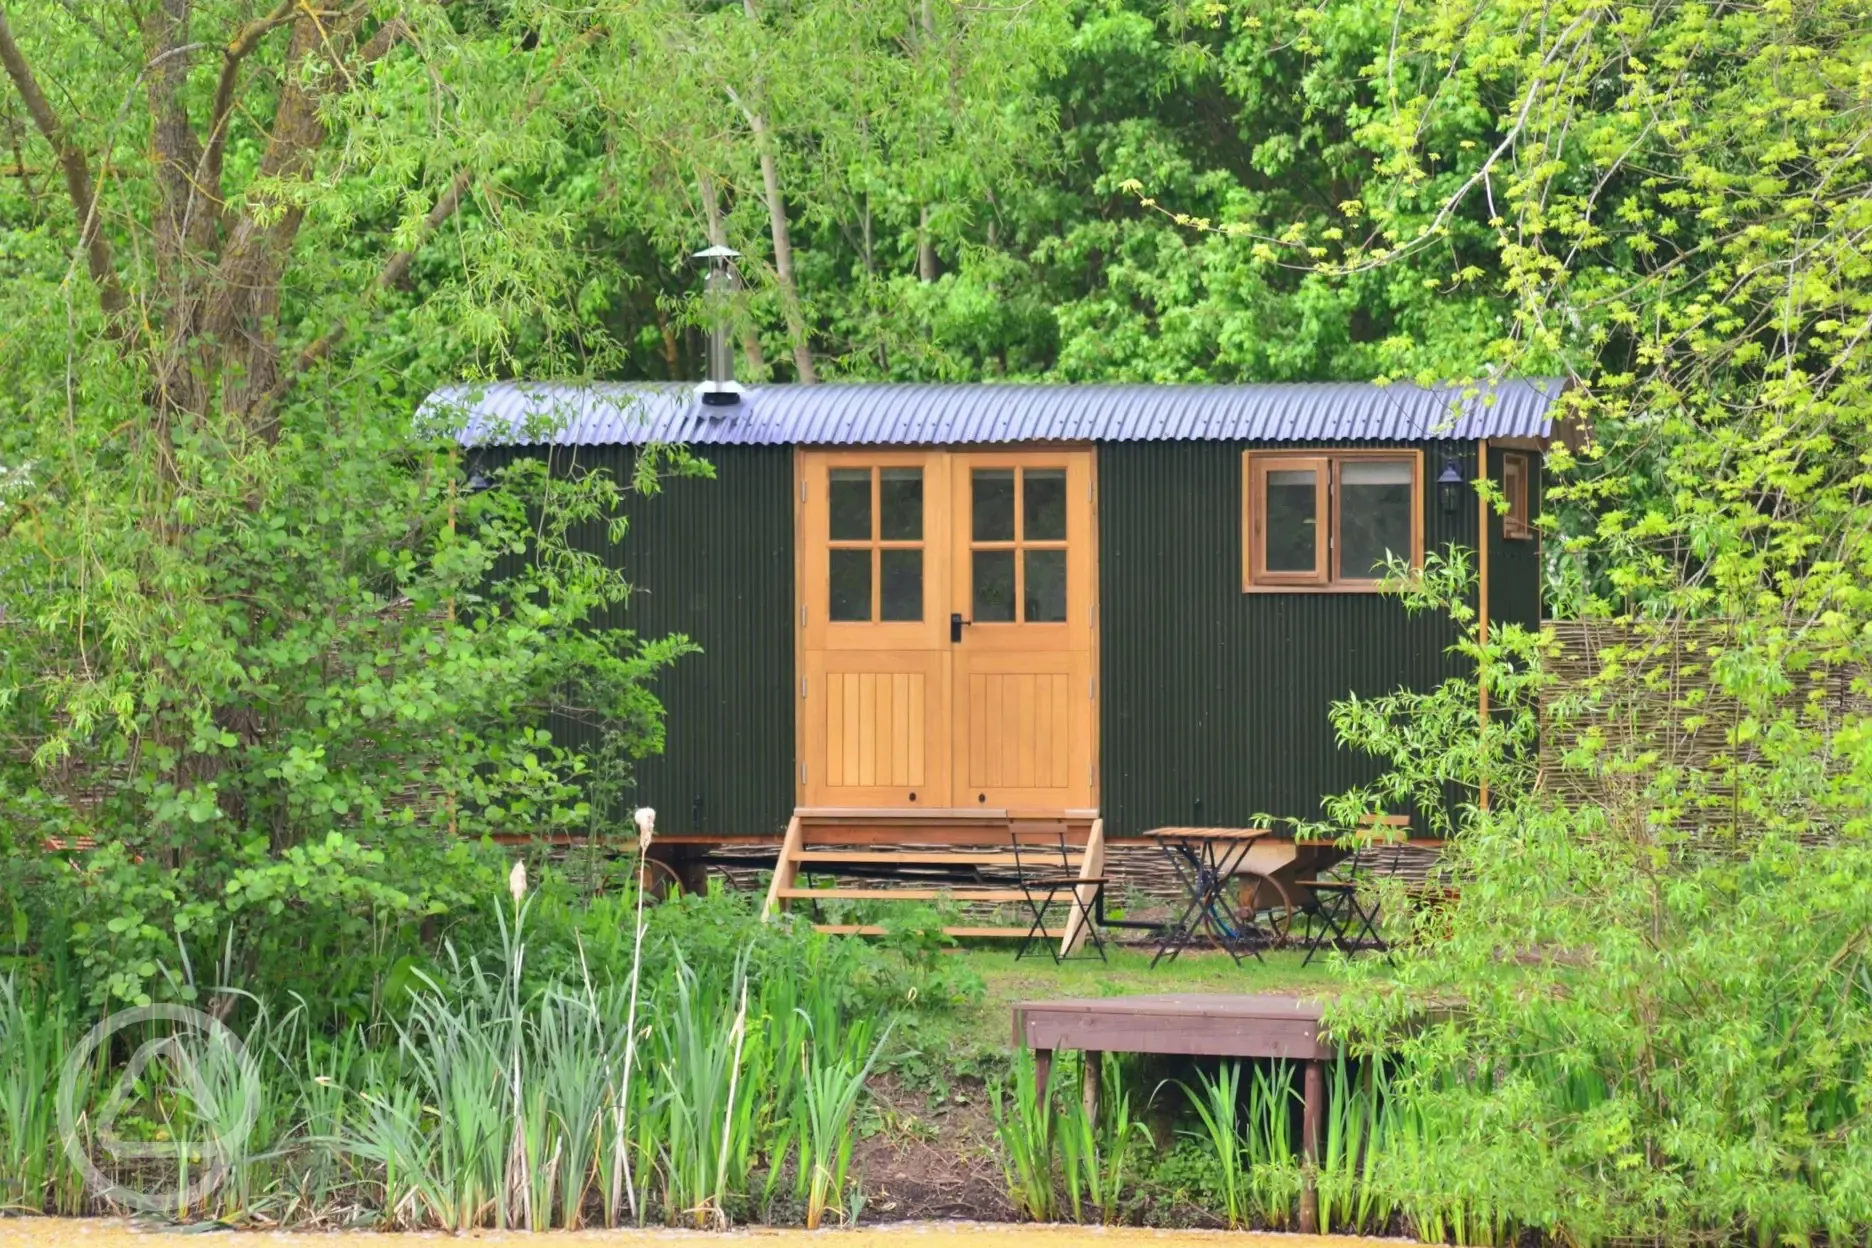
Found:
[797,449,1097,810]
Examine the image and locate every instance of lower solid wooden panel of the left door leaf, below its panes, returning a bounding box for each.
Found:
[803,649,949,806]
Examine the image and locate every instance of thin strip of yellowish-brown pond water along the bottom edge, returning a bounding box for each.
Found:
[0,1218,1404,1248]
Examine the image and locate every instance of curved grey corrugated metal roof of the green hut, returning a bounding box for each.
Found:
[423,378,1561,445]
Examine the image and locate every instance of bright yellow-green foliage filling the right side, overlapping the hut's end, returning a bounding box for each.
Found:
[1280,0,1872,1242]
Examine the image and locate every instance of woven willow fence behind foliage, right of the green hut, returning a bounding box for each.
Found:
[1541,621,1872,851]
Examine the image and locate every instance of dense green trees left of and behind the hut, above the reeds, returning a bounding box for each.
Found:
[0,0,1507,997]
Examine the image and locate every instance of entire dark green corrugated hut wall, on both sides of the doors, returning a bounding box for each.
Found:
[501,442,1539,836]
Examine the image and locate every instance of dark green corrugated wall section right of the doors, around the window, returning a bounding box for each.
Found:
[1099,442,1494,836]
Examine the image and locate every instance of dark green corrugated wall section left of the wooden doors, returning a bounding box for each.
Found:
[524,447,796,833]
